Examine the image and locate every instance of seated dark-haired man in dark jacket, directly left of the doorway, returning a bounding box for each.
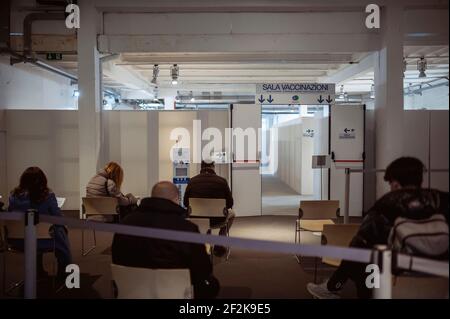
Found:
[183,161,235,256]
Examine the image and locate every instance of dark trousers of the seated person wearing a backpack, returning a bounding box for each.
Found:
[327,260,372,299]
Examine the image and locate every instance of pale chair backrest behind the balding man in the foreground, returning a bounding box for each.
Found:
[111,264,193,299]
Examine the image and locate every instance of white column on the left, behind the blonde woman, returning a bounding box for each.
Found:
[78,0,102,215]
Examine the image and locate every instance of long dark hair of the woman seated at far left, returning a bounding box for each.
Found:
[12,167,50,203]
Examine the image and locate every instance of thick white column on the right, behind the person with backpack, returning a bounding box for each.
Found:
[374,4,403,196]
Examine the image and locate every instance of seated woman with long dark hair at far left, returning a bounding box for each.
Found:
[8,167,72,279]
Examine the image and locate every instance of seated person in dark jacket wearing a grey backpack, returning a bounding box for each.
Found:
[307,157,448,299]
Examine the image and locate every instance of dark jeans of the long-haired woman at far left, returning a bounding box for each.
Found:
[8,225,72,276]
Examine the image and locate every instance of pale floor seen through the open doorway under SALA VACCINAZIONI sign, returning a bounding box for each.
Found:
[261,175,313,216]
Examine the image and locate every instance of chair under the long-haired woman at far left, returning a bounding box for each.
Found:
[2,219,56,295]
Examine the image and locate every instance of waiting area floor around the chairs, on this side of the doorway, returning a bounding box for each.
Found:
[0,216,353,299]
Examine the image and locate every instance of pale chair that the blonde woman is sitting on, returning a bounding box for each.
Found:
[81,197,120,256]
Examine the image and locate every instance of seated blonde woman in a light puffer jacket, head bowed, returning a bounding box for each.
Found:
[86,162,137,218]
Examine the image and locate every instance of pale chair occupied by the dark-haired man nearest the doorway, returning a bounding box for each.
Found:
[188,198,231,260]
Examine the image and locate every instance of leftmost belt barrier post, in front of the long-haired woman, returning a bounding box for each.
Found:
[24,209,39,299]
